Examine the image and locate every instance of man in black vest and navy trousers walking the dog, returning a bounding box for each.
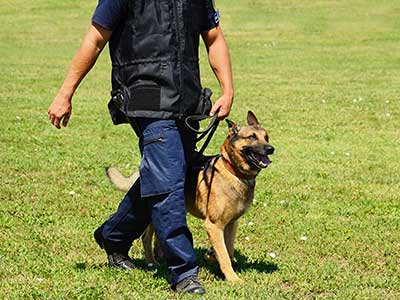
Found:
[48,0,233,294]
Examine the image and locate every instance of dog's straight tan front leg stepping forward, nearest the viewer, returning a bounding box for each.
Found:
[205,218,243,283]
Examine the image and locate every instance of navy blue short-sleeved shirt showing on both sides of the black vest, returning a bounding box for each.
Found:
[92,0,219,32]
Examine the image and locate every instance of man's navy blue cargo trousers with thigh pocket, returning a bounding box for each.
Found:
[95,119,198,285]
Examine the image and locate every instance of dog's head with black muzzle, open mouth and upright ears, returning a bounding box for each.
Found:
[221,111,275,177]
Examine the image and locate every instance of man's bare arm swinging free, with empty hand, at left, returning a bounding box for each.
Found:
[47,23,112,128]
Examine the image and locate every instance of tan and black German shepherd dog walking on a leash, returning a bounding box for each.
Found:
[107,111,274,283]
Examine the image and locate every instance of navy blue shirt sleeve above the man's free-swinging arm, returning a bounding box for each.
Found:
[92,0,128,31]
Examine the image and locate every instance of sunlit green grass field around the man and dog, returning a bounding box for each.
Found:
[0,0,400,300]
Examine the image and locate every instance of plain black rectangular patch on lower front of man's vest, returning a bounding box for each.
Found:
[128,86,161,113]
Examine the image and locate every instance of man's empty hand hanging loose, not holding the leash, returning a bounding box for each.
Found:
[47,94,72,129]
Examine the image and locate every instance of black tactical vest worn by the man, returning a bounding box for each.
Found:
[109,0,206,124]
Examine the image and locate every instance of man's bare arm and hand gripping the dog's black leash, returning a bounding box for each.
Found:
[201,26,234,120]
